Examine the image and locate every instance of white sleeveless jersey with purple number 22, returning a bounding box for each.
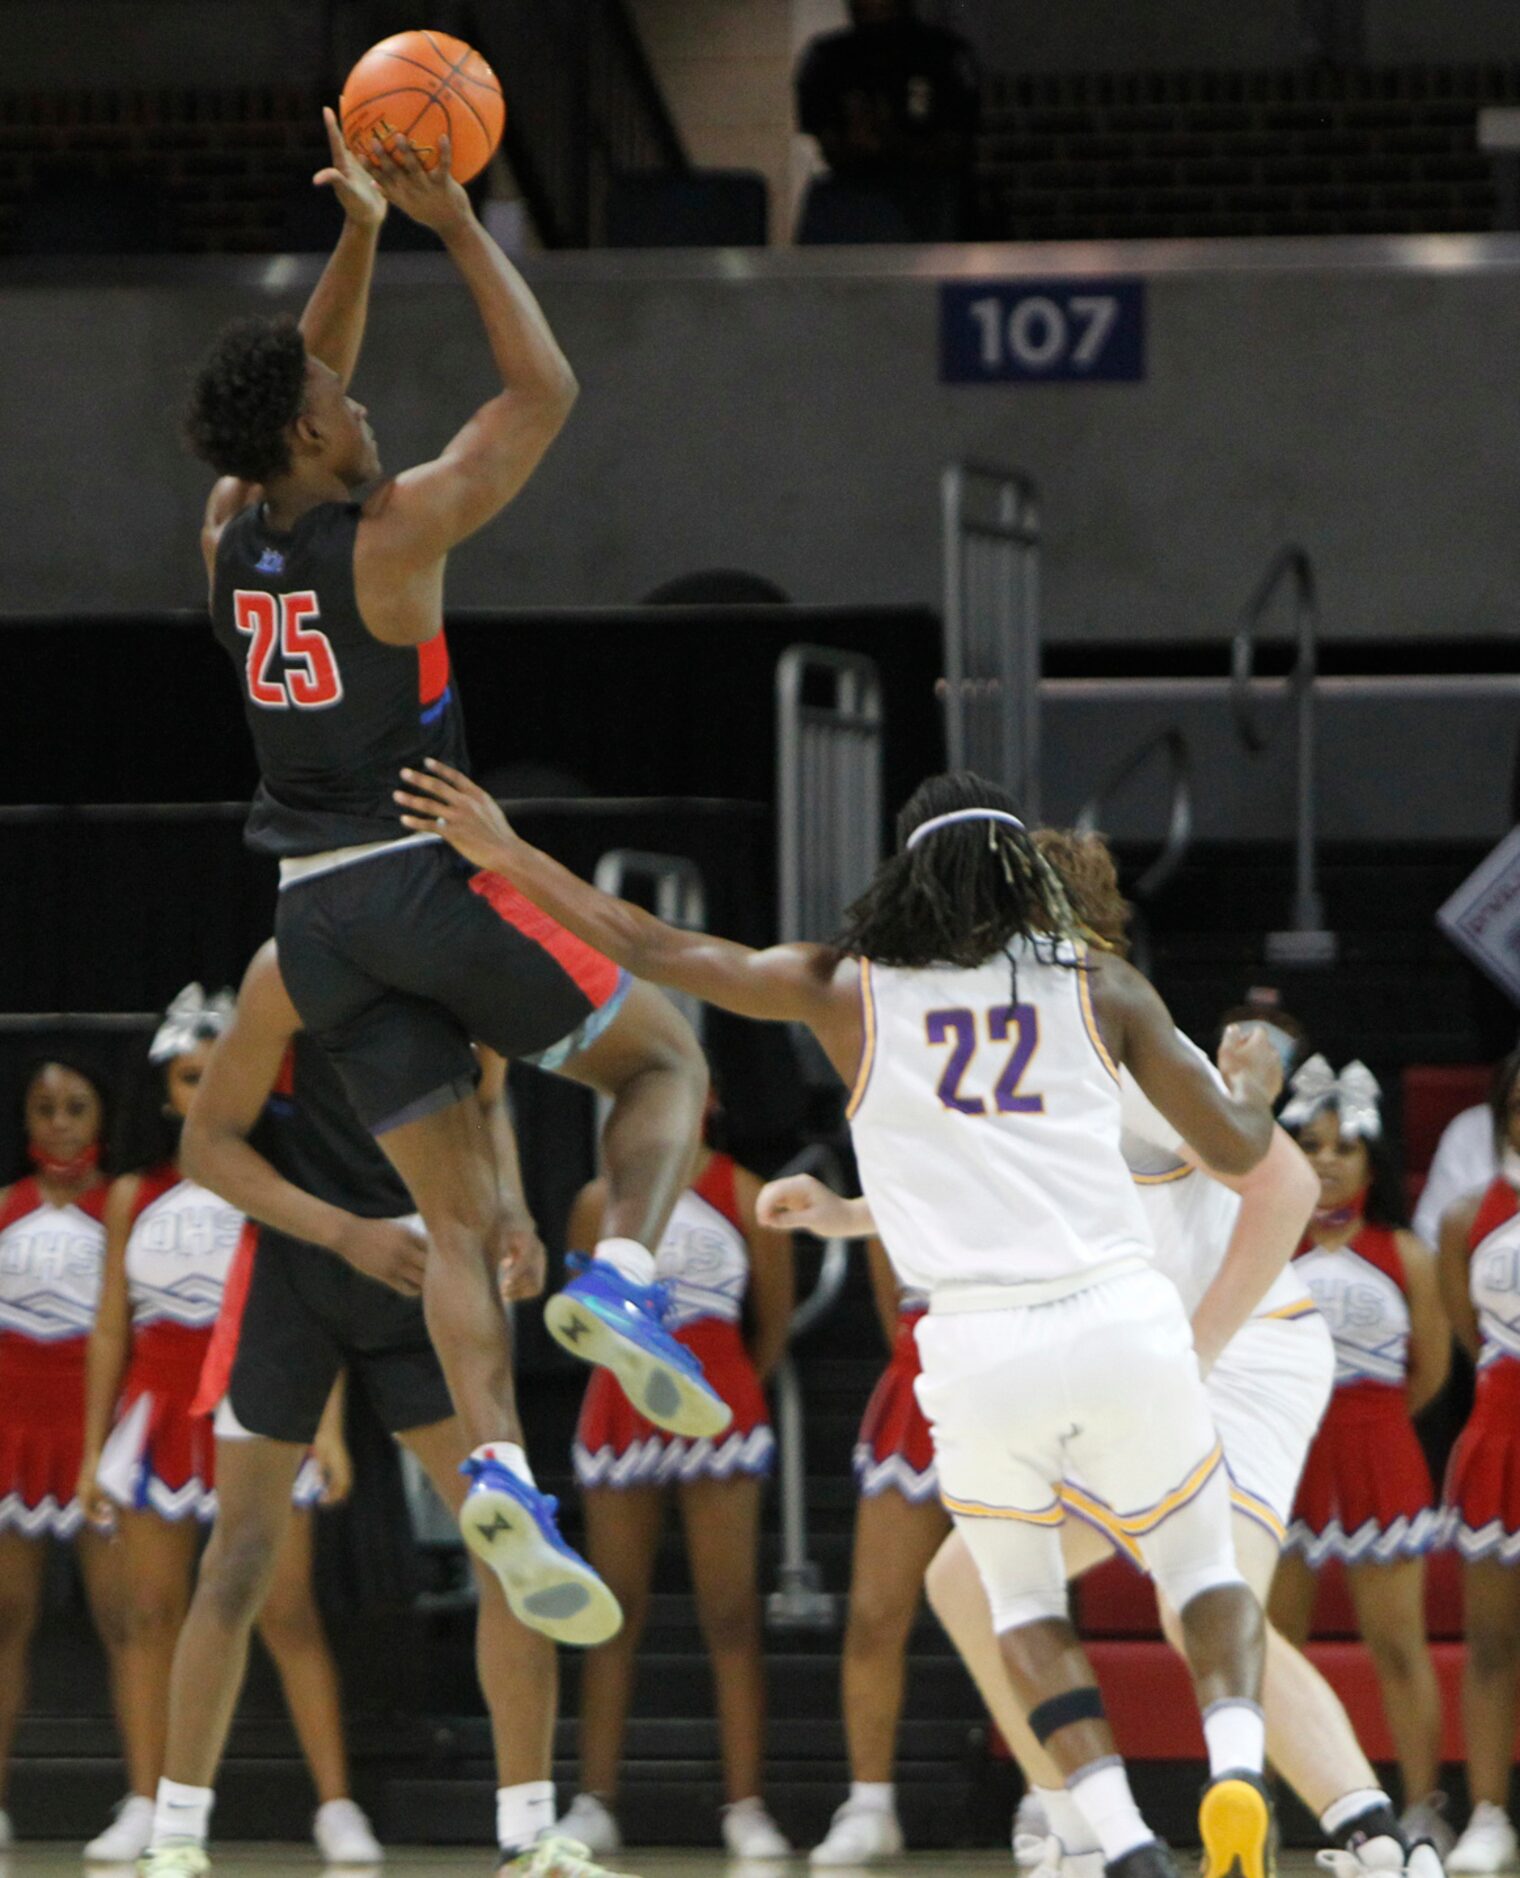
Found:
[849,941,1150,1294]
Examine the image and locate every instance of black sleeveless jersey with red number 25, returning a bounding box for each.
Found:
[210,501,468,854]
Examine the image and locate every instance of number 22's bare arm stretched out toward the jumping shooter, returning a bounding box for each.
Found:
[396,759,862,1082]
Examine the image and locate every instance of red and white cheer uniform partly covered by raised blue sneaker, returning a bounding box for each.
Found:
[575,1153,776,1487]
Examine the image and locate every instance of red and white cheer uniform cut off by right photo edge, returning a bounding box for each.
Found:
[1445,1176,1520,1564]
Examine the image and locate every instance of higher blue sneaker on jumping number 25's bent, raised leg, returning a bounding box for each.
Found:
[543,1253,733,1440]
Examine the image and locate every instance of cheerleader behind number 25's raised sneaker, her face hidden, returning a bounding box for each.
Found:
[560,1147,793,1857]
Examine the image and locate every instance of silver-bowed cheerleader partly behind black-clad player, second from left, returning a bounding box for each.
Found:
[79,984,370,1863]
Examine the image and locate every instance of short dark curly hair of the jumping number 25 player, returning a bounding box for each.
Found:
[184,317,306,483]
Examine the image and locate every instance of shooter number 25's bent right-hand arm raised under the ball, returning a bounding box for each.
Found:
[355,137,579,575]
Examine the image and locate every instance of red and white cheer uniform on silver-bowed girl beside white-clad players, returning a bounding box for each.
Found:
[1289,1224,1439,1566]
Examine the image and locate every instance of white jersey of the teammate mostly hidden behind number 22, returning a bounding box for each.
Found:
[1120,1031,1313,1316]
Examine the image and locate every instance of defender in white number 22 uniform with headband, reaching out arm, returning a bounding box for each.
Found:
[398,762,1281,1878]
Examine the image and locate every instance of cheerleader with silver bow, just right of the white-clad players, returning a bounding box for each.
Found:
[1270,1057,1450,1807]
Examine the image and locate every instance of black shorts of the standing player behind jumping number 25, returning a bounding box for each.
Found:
[227,1226,455,1446]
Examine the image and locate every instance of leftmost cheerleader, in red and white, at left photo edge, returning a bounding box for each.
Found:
[0,1055,143,1857]
